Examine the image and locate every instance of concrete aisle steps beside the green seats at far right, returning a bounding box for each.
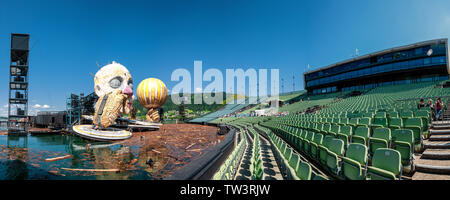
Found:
[413,111,450,180]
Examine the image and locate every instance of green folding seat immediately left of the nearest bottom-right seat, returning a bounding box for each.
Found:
[342,143,367,180]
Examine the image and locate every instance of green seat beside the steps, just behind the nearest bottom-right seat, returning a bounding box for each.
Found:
[392,129,414,166]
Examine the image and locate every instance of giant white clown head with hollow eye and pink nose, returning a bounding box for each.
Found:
[94,61,134,113]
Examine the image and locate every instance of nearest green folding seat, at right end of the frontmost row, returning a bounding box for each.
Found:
[367,148,402,180]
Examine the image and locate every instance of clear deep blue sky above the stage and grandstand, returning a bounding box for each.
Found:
[0,0,450,115]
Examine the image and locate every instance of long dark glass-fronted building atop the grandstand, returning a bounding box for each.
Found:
[303,38,450,94]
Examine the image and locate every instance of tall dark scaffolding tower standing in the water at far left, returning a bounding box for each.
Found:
[8,33,30,135]
